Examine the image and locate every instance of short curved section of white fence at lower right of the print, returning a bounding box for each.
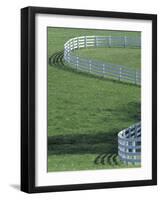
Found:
[118,123,141,164]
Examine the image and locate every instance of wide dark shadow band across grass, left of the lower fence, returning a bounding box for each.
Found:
[48,131,117,155]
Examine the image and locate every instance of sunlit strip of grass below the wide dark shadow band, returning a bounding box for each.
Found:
[48,153,139,172]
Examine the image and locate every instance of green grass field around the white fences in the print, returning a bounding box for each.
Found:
[48,28,140,171]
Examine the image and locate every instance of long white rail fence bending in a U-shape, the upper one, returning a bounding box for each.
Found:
[64,36,141,85]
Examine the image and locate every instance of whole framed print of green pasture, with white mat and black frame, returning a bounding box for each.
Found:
[21,7,157,193]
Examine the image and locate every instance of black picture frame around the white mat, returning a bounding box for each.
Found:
[21,7,157,193]
